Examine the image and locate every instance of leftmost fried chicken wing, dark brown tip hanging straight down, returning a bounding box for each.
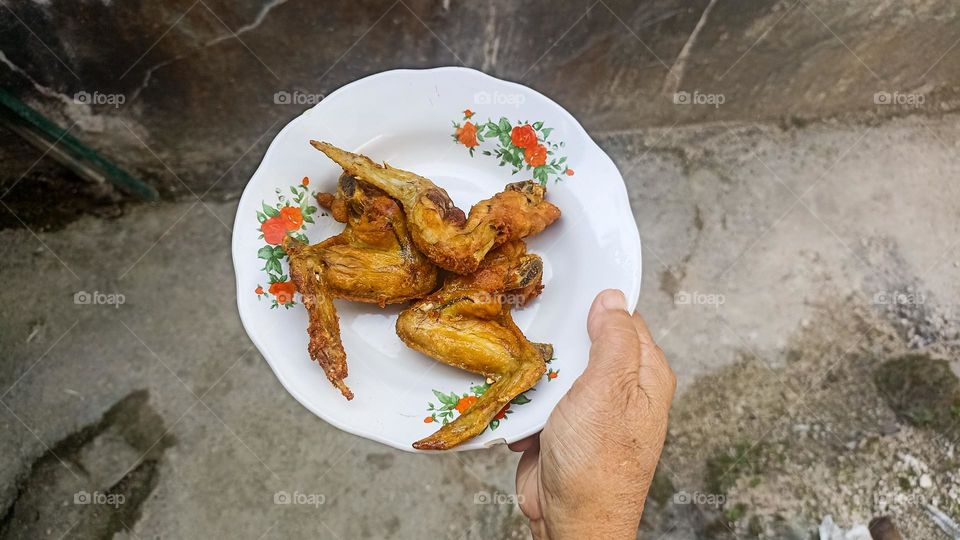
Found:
[283,174,438,399]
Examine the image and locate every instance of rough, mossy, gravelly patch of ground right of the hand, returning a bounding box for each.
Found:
[643,286,960,539]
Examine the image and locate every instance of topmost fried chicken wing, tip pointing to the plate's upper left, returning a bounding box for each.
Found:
[310,141,560,274]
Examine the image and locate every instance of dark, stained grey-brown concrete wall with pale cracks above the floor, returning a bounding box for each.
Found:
[0,0,960,199]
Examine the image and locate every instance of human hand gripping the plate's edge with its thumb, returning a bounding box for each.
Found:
[510,289,677,540]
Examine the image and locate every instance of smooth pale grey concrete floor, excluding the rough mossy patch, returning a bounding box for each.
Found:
[0,108,960,538]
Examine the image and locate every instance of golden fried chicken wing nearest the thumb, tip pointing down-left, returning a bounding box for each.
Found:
[397,240,553,450]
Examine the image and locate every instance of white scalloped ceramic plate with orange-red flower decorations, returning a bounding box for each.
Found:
[233,68,640,451]
